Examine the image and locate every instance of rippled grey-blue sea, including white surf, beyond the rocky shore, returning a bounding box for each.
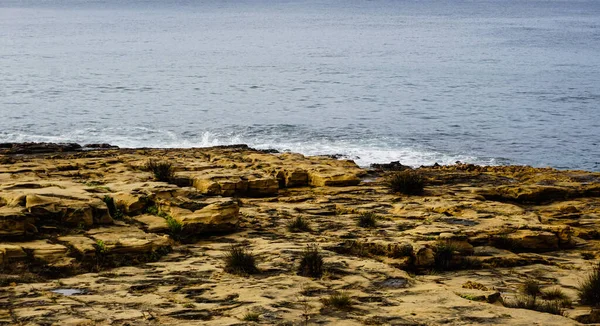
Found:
[0,0,600,171]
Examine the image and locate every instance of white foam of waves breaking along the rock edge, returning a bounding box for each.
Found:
[0,127,498,166]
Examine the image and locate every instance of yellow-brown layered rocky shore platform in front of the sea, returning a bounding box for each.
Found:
[0,144,600,326]
